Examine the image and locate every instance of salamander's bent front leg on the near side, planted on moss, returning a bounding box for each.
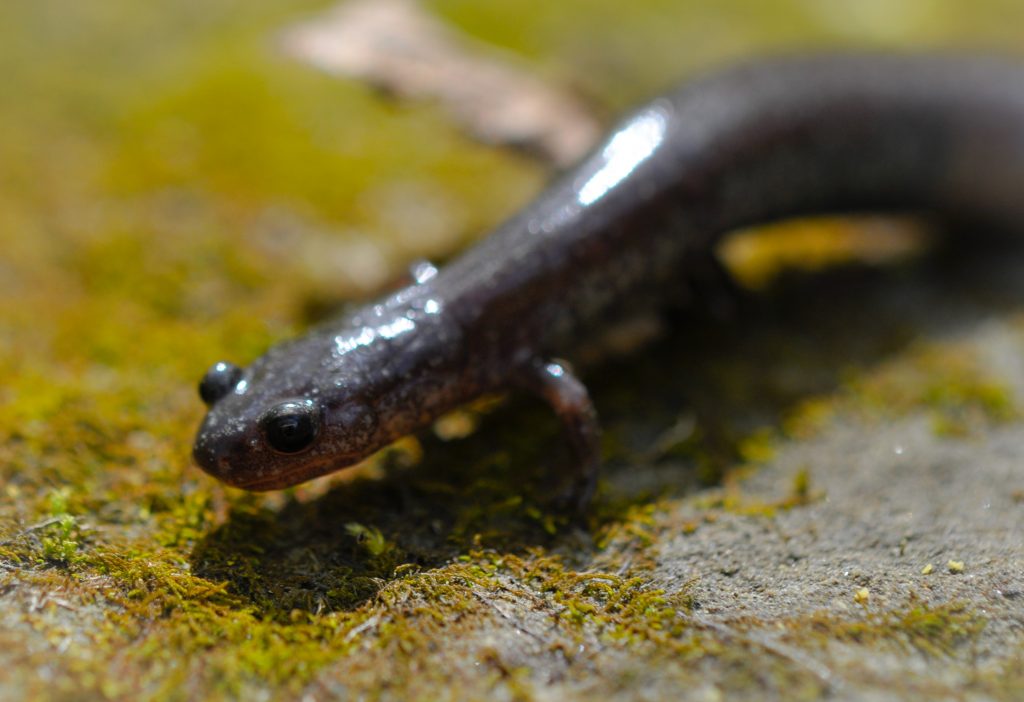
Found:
[519,360,601,513]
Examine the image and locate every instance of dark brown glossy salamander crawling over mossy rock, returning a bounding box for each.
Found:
[194,55,1024,508]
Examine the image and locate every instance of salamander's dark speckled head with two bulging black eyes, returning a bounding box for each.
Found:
[193,336,383,490]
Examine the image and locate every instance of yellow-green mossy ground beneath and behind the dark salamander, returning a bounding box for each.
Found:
[0,0,1024,699]
